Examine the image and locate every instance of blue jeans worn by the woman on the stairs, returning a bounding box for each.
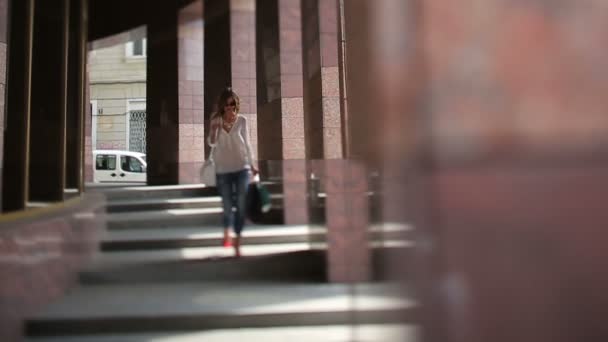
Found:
[216,169,249,236]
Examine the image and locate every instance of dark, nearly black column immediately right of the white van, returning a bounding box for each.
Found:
[146,2,179,185]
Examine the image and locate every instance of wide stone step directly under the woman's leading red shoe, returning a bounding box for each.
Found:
[80,243,411,284]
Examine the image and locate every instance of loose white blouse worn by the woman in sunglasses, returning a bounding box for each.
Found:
[207,115,254,173]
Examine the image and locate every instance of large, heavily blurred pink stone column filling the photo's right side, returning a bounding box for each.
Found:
[423,0,608,342]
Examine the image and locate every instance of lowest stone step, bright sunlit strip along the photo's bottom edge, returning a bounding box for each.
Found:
[26,324,419,342]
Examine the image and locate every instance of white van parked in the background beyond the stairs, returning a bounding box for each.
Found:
[93,150,148,183]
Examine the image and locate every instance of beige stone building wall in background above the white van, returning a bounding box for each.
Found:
[89,44,146,149]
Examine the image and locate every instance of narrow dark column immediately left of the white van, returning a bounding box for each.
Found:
[65,0,89,192]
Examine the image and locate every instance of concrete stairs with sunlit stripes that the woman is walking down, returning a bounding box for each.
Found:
[26,185,416,342]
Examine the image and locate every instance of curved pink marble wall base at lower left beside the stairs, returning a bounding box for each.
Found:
[0,195,105,341]
